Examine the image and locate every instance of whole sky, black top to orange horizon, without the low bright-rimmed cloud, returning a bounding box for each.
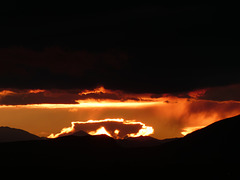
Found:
[0,0,240,138]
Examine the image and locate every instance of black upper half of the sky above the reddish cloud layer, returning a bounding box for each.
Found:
[0,1,240,93]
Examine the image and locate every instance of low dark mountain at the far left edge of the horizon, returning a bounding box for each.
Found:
[0,126,41,142]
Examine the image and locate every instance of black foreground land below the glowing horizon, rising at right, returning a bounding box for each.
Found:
[0,116,240,176]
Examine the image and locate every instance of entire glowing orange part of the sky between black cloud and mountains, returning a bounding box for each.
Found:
[0,86,240,139]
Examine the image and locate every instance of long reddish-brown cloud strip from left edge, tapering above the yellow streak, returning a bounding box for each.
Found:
[0,86,141,105]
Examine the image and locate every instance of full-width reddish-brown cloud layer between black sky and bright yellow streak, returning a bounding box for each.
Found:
[0,84,240,105]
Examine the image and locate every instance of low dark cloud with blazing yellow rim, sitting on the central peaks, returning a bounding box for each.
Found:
[48,119,154,139]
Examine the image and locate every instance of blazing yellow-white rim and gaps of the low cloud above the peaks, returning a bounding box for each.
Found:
[48,118,154,139]
